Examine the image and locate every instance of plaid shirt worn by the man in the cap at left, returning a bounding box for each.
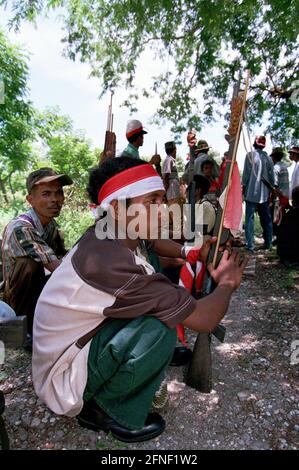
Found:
[2,209,66,288]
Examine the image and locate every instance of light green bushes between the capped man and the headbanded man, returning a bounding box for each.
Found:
[36,108,98,239]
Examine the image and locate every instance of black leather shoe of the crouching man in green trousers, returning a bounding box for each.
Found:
[77,400,165,442]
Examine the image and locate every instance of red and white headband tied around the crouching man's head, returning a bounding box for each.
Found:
[98,164,164,209]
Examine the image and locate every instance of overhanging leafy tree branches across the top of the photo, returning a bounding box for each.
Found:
[0,0,299,144]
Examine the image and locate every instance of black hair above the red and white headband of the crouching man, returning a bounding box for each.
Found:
[87,157,147,204]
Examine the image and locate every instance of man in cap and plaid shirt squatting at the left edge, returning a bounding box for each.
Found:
[2,168,73,334]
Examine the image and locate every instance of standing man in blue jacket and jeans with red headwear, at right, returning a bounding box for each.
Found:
[242,135,274,252]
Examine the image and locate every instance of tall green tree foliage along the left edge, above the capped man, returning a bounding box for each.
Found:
[0,31,33,202]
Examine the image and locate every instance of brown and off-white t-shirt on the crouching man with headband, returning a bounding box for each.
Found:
[32,227,195,416]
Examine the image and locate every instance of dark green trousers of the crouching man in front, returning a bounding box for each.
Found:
[83,316,176,429]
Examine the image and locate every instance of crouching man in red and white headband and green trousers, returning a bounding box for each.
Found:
[33,157,246,442]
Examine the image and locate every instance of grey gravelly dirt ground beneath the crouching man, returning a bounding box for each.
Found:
[0,248,299,450]
